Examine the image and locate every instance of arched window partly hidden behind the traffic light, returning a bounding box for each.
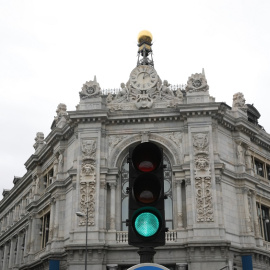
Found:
[121,153,173,231]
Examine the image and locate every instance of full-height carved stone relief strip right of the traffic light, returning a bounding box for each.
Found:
[193,133,214,222]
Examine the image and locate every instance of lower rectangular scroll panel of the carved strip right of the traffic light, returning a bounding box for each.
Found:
[195,177,214,222]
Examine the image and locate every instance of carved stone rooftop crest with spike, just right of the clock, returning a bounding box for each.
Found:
[186,70,209,93]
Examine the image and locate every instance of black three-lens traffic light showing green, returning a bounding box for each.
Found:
[128,142,166,247]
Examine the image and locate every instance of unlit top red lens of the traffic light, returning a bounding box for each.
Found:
[132,142,162,172]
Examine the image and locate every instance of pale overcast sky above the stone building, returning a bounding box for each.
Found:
[0,0,270,199]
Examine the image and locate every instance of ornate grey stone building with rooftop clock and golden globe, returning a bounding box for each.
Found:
[0,30,270,270]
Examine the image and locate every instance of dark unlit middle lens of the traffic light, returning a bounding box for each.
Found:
[134,174,161,204]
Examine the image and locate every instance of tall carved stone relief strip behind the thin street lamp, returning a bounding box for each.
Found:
[79,140,97,226]
